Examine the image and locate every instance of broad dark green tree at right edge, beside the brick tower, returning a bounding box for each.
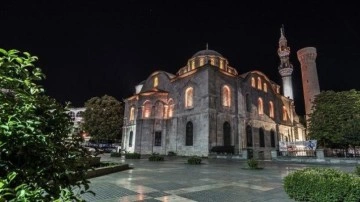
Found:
[309,90,360,148]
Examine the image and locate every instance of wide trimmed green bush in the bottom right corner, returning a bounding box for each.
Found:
[284,168,360,202]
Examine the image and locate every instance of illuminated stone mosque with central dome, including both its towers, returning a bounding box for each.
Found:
[122,28,319,159]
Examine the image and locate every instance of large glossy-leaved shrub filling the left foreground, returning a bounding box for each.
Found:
[0,49,89,201]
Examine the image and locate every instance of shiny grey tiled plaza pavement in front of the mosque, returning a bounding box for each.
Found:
[83,154,354,202]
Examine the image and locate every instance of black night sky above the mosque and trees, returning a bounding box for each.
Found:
[0,0,360,114]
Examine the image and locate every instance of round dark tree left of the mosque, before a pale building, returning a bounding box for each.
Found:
[83,95,124,144]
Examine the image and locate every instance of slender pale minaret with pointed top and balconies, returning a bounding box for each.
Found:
[278,25,294,100]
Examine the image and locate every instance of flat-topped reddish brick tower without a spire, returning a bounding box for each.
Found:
[297,47,320,120]
